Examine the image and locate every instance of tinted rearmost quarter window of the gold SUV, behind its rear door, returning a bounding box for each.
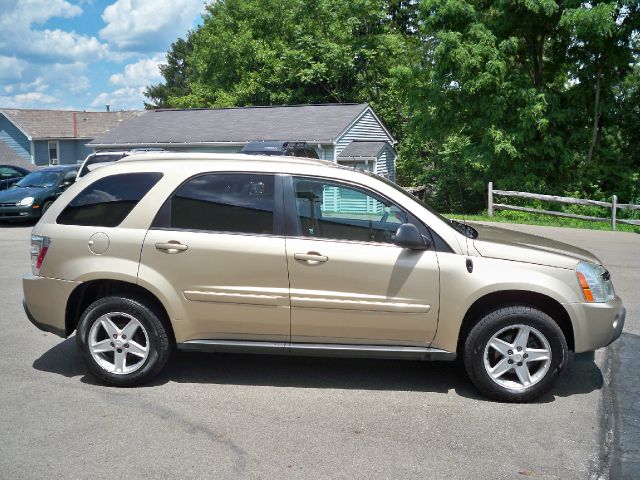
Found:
[57,172,162,227]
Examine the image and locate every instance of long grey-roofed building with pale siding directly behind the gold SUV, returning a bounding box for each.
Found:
[88,103,397,180]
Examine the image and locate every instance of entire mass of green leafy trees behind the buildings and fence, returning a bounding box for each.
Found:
[147,0,640,211]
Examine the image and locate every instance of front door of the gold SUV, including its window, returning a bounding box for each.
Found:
[286,177,440,346]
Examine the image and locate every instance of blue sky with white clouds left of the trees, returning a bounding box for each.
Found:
[0,0,210,111]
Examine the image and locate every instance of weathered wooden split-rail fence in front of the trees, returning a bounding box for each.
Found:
[487,182,640,230]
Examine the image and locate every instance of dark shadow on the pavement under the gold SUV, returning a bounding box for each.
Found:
[33,337,603,403]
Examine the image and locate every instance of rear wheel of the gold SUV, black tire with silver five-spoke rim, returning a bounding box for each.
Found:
[76,297,171,387]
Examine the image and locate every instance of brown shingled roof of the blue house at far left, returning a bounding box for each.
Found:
[0,109,142,140]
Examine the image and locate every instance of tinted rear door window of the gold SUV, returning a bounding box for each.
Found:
[165,173,275,234]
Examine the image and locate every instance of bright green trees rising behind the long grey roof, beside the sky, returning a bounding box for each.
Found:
[147,0,416,134]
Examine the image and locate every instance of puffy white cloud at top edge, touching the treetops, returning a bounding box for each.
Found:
[100,0,204,52]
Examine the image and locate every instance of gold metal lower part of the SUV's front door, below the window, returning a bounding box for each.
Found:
[287,238,439,346]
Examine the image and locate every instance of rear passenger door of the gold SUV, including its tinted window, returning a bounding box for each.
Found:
[140,172,290,342]
